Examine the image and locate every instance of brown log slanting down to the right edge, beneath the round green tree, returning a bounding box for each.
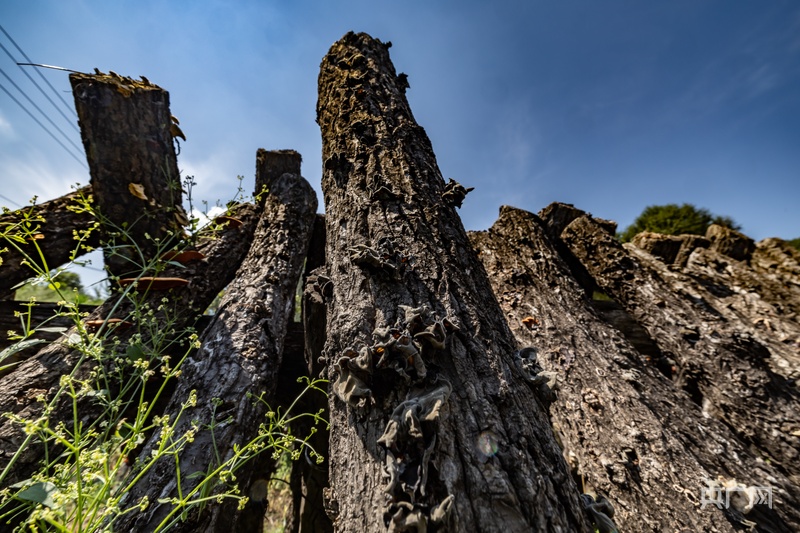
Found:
[542,205,800,482]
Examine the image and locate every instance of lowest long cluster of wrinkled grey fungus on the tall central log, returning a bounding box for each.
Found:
[378,380,453,532]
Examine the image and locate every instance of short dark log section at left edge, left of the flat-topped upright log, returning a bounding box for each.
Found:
[0,187,100,298]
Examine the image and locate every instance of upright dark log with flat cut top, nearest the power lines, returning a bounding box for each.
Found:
[69,73,188,277]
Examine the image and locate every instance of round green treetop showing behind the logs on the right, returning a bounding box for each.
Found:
[618,204,741,242]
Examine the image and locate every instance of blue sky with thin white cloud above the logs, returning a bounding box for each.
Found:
[0,0,800,284]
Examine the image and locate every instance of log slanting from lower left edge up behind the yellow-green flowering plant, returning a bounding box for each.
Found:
[0,205,256,487]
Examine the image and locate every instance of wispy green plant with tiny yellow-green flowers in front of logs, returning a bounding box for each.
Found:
[0,187,325,532]
